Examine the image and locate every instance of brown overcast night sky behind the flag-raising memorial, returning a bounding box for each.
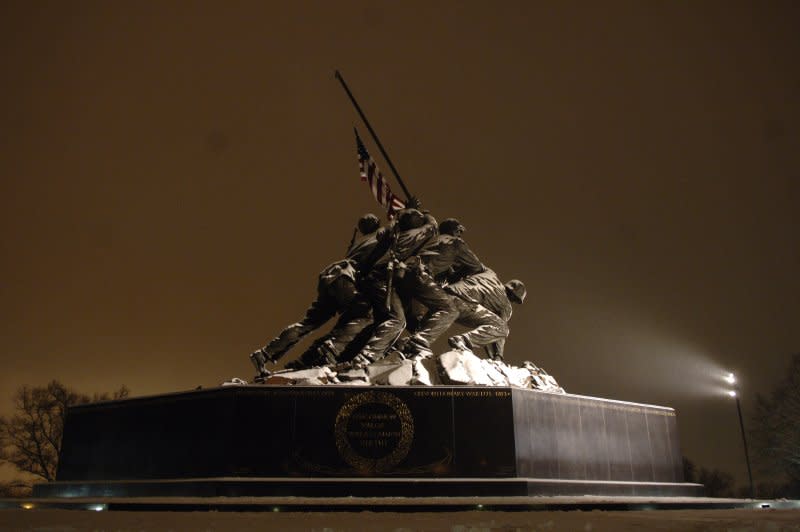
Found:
[0,1,800,481]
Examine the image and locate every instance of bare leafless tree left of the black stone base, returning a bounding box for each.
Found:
[0,380,129,481]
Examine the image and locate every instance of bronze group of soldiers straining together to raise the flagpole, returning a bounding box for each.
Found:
[250,200,526,381]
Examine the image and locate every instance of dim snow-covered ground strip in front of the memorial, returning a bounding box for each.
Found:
[0,509,800,532]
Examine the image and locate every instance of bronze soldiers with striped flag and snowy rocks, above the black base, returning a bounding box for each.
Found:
[238,120,563,393]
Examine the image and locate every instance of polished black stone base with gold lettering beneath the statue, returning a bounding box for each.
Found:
[35,386,699,497]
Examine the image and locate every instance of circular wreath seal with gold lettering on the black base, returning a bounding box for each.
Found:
[334,391,414,474]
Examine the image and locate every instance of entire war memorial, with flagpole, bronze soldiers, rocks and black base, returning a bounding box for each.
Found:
[34,72,702,498]
